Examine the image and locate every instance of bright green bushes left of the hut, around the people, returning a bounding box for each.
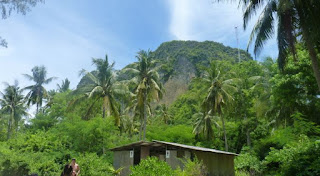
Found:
[0,118,134,176]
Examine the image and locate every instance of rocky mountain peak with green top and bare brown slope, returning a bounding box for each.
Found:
[153,41,252,105]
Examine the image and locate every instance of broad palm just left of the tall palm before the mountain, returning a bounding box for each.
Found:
[76,55,121,126]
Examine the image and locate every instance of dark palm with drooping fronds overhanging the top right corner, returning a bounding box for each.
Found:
[232,0,320,90]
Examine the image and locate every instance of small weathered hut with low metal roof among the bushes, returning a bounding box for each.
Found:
[111,140,237,176]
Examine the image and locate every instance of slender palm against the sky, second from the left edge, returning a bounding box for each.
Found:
[23,66,56,113]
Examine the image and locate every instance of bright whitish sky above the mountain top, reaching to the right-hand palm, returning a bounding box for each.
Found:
[166,0,277,57]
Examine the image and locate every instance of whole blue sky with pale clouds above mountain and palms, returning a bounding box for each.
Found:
[0,0,277,90]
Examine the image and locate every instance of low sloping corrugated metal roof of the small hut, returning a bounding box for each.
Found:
[110,140,237,155]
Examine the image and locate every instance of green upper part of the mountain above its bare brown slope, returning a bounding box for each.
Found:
[153,41,252,81]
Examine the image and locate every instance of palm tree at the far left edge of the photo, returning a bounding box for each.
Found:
[0,81,28,139]
